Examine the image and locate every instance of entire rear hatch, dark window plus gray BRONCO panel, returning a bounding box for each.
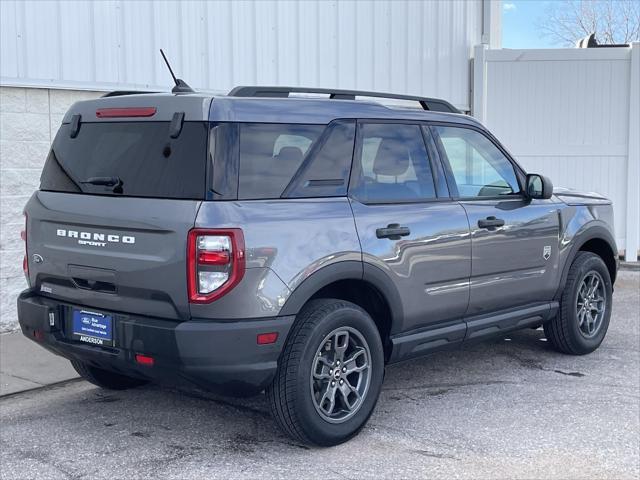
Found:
[25,101,208,320]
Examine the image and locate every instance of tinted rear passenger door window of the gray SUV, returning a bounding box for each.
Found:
[351,123,436,203]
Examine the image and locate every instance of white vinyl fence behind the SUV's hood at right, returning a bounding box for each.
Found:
[473,43,640,261]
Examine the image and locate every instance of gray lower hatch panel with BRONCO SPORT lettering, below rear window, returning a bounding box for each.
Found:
[27,192,199,319]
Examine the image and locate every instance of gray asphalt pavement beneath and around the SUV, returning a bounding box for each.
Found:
[0,272,640,480]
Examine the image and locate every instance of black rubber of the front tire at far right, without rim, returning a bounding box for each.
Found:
[544,252,613,355]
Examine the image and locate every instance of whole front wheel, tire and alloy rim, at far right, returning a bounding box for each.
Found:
[544,252,613,355]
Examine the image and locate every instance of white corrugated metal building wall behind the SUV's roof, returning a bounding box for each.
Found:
[0,0,490,110]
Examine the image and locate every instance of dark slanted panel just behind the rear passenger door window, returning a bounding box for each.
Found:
[287,121,356,197]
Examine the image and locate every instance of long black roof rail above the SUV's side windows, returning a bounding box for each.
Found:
[228,86,461,113]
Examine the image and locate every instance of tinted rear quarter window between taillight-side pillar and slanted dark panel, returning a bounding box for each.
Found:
[238,123,325,199]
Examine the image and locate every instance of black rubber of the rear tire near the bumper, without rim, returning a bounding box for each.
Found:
[266,299,384,446]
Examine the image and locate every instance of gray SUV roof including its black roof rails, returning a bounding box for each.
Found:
[72,87,480,125]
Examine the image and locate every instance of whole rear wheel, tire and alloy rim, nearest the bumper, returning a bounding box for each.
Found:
[267,299,384,446]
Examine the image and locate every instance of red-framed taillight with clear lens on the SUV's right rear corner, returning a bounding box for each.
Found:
[187,228,245,303]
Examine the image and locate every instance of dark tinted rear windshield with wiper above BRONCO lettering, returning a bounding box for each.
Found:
[40,122,208,200]
